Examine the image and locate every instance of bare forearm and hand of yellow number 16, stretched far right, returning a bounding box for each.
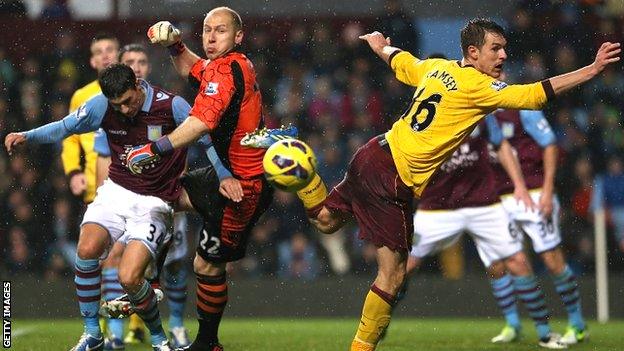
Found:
[549,42,622,94]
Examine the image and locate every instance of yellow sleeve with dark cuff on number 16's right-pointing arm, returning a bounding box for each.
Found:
[468,74,554,111]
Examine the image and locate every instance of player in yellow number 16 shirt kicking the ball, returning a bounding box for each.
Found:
[297,19,620,351]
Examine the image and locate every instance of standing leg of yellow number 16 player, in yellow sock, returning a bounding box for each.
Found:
[351,246,407,351]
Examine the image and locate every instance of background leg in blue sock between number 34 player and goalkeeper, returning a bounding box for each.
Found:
[163,212,190,347]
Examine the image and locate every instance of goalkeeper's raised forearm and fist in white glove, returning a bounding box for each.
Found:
[147,21,200,78]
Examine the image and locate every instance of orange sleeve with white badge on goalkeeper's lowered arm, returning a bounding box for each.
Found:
[190,61,236,130]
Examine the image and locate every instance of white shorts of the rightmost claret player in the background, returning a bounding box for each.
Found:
[501,189,561,253]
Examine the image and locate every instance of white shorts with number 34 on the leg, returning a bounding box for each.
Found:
[81,179,173,259]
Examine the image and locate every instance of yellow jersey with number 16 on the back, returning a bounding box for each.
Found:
[386,51,552,197]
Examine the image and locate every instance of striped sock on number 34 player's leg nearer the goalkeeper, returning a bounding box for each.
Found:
[128,279,167,345]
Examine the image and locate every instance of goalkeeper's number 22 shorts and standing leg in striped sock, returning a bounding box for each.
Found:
[177,167,273,351]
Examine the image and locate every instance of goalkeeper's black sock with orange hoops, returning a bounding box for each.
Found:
[193,273,228,344]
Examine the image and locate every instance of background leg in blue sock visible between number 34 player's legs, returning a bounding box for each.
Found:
[102,241,125,350]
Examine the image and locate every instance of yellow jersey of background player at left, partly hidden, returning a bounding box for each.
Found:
[61,80,102,203]
